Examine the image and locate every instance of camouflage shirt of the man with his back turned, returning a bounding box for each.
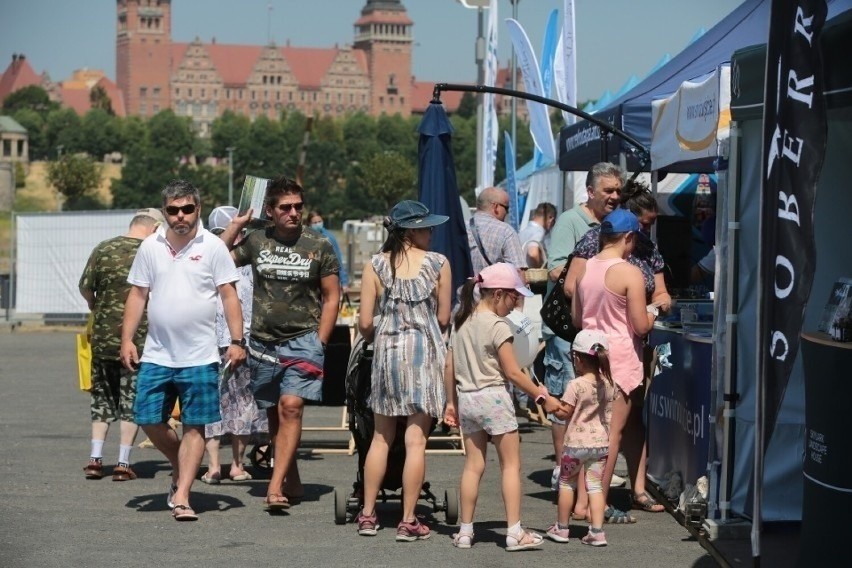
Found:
[79,236,148,361]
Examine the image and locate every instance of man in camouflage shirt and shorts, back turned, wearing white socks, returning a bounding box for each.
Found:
[79,208,164,481]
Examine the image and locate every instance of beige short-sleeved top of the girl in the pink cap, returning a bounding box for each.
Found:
[451,310,514,392]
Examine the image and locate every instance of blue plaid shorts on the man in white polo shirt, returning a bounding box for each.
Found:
[133,363,222,426]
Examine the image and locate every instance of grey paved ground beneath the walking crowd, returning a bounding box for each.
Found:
[0,329,716,568]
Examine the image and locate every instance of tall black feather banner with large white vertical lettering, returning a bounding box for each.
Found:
[758,0,827,451]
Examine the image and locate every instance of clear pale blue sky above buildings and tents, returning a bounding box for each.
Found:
[0,0,740,102]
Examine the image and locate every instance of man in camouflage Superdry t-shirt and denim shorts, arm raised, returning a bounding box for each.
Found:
[221,177,340,510]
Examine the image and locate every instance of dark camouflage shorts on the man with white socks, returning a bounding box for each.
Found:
[90,359,136,422]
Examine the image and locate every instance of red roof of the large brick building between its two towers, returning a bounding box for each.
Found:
[172,43,367,89]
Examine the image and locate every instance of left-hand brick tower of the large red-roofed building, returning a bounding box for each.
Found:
[115,0,172,116]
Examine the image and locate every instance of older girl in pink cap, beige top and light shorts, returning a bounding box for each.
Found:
[444,262,561,552]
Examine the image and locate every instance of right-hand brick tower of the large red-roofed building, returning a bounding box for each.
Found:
[354,0,414,116]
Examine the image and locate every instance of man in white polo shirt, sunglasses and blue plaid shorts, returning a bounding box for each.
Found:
[121,180,246,521]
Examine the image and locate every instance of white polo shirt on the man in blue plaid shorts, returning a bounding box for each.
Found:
[127,226,239,368]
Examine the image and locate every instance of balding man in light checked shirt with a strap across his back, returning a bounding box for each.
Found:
[467,187,527,274]
